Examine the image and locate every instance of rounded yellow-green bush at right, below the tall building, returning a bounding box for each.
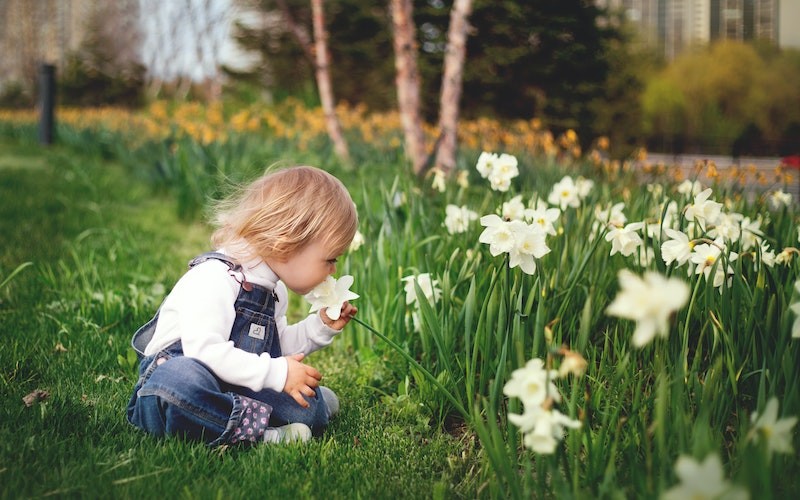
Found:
[642,41,800,155]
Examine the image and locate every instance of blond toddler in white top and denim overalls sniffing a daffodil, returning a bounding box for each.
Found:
[127,167,358,445]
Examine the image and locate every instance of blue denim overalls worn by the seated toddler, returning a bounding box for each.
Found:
[127,252,328,446]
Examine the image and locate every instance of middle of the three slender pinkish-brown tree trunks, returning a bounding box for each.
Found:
[390,0,426,174]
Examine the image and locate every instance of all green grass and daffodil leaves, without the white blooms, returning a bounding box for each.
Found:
[0,112,800,498]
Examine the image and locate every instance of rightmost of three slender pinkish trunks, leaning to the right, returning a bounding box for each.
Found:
[436,0,472,175]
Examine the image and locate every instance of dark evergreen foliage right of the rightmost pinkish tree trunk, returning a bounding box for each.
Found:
[464,0,616,137]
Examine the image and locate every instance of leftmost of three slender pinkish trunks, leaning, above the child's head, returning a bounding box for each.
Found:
[311,0,350,163]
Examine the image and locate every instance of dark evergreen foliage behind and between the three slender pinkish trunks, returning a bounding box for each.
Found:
[231,0,617,143]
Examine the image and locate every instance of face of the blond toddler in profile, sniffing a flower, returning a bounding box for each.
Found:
[267,242,339,295]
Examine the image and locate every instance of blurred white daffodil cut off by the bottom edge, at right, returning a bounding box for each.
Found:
[661,454,749,500]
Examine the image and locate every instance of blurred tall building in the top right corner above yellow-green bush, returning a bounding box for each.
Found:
[596,0,800,60]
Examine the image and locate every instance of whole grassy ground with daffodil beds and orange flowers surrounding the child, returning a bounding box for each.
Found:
[0,102,800,498]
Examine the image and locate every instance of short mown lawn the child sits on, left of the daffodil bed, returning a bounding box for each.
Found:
[0,141,482,498]
